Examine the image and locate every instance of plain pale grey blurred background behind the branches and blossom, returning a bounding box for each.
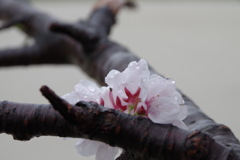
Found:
[0,0,240,160]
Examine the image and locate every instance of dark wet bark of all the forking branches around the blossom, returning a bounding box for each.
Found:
[0,0,240,160]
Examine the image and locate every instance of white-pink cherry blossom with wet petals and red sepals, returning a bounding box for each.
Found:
[63,59,187,160]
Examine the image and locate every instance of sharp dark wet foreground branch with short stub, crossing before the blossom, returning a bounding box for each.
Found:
[0,86,239,160]
